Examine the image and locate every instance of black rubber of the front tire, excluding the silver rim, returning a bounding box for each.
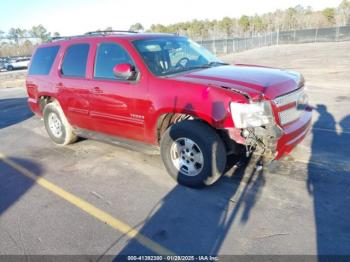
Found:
[161,120,226,187]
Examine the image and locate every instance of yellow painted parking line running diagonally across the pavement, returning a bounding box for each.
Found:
[0,152,173,255]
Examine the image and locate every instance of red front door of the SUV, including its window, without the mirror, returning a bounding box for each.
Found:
[90,41,147,140]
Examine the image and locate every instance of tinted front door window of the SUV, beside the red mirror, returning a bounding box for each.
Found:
[95,43,134,79]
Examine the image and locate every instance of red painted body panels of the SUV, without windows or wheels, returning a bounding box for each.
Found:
[26,34,311,157]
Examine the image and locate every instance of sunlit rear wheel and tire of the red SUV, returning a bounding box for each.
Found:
[43,101,78,146]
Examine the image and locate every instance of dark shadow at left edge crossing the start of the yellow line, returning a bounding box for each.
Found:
[0,157,43,219]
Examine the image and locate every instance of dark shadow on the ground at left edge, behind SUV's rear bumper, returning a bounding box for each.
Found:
[0,97,33,129]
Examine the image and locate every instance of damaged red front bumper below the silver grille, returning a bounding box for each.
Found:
[275,111,312,160]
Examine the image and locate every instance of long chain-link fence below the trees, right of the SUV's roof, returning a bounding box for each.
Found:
[197,26,350,54]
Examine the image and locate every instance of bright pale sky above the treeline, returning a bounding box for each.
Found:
[0,0,341,35]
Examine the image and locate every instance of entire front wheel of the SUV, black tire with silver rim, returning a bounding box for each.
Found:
[160,120,226,187]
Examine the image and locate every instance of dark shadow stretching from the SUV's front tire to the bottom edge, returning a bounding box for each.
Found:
[97,155,265,261]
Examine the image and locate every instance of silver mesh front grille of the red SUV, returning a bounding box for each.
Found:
[274,88,304,125]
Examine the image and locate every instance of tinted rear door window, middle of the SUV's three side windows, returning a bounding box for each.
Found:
[61,44,89,77]
